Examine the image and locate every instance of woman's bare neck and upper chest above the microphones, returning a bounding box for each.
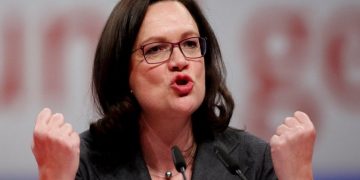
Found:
[140,116,196,179]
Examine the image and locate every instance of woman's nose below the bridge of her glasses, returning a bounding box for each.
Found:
[168,46,189,71]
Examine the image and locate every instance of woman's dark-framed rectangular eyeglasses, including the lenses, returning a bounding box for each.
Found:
[133,37,206,64]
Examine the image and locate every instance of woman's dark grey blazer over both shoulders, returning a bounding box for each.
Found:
[76,128,277,180]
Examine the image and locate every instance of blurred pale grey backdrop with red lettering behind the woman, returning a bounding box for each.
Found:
[0,0,360,179]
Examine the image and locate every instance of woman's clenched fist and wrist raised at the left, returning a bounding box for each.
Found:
[32,108,80,180]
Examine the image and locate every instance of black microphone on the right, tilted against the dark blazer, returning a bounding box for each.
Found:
[215,147,247,180]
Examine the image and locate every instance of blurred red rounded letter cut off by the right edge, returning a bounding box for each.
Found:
[323,7,360,112]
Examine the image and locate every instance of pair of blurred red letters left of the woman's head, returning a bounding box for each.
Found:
[0,8,104,110]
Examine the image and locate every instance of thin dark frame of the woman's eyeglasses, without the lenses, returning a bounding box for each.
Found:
[132,36,207,64]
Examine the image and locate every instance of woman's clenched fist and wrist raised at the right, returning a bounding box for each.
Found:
[270,111,316,180]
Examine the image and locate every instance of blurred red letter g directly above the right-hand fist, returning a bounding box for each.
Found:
[245,7,320,139]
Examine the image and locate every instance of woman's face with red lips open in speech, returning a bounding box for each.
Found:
[130,1,205,118]
